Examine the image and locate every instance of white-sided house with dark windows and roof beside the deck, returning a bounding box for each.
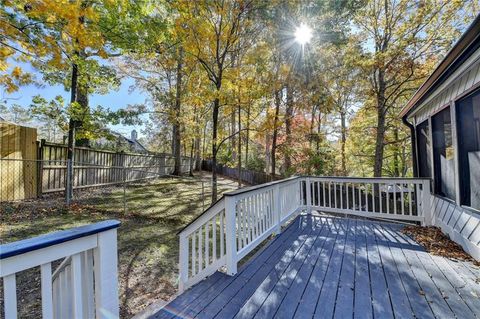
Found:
[401,16,480,259]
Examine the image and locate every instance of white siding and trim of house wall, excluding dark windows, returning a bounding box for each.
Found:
[409,43,480,261]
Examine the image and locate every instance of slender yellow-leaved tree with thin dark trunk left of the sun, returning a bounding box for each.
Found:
[178,0,255,202]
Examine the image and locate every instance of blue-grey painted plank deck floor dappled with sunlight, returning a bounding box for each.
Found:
[152,215,480,319]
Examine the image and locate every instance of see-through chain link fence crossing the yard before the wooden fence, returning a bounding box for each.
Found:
[0,158,237,214]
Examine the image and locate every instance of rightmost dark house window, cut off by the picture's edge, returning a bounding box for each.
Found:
[456,91,480,209]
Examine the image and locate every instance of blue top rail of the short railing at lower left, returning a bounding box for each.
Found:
[0,220,120,259]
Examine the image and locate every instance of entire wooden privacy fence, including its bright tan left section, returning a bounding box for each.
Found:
[0,126,191,201]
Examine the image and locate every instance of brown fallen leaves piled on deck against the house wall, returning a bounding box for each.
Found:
[402,226,480,266]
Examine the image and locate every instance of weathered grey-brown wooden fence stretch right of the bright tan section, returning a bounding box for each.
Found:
[40,142,190,193]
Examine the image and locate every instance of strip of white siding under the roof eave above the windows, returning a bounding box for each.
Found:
[409,49,480,124]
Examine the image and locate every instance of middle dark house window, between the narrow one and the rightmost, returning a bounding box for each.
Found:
[432,108,455,199]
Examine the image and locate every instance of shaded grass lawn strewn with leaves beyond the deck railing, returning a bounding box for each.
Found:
[0,174,237,318]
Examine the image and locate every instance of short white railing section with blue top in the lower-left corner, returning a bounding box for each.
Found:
[0,220,120,319]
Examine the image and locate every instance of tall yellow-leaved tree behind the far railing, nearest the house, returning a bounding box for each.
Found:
[355,0,476,177]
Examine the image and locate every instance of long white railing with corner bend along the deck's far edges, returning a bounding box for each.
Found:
[179,177,431,291]
